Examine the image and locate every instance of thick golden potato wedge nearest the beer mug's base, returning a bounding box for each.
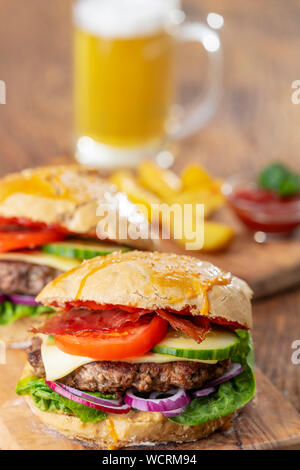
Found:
[137,160,181,201]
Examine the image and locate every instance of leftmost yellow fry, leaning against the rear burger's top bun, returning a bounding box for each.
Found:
[110,170,160,219]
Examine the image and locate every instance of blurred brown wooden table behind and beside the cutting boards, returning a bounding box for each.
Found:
[0,0,300,436]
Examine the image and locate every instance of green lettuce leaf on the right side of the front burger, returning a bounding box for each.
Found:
[170,329,255,426]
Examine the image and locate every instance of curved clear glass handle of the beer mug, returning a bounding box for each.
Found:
[171,22,223,139]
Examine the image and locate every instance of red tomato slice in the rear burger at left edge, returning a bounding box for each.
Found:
[0,230,66,253]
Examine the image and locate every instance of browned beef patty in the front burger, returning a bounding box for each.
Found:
[28,338,230,394]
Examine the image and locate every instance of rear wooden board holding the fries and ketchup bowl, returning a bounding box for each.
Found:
[162,208,300,299]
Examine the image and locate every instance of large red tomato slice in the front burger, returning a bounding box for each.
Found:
[55,315,168,361]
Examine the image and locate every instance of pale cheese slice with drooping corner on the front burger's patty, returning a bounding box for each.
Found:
[41,336,218,381]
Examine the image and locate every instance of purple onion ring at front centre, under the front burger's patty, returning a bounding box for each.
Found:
[124,389,191,413]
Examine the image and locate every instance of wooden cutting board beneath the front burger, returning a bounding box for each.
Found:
[0,350,300,450]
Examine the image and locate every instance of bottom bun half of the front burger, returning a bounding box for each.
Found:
[26,397,231,449]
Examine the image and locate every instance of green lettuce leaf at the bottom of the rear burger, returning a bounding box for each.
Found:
[0,300,54,325]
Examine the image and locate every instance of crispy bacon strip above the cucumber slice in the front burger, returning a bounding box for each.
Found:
[156,310,209,343]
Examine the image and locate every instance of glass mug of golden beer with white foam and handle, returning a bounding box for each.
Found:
[73,0,222,168]
